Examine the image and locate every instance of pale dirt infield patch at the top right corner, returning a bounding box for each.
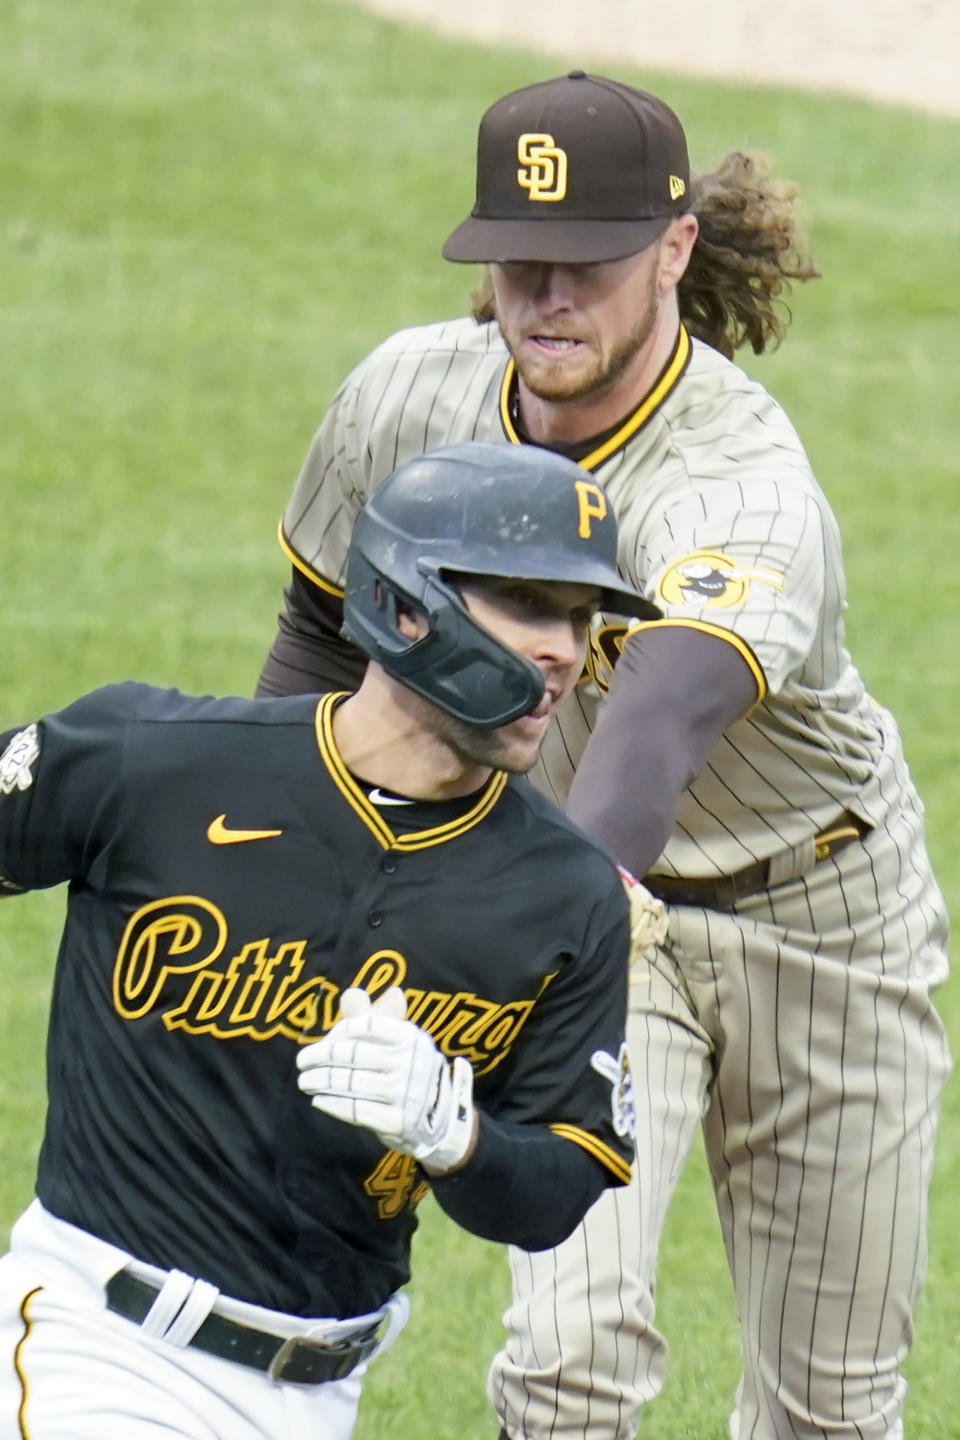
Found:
[356,0,960,117]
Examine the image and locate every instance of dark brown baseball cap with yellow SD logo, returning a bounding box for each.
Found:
[443,71,691,265]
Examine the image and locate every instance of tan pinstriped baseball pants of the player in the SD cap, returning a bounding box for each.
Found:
[488,804,950,1440]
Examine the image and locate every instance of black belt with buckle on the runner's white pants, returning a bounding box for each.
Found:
[107,1270,380,1385]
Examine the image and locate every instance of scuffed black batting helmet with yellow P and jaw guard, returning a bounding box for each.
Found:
[343,442,661,729]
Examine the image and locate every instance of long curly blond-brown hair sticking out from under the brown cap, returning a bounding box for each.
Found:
[471,150,820,359]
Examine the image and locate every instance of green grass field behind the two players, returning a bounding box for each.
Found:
[0,0,960,1440]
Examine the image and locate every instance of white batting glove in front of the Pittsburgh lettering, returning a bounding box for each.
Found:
[296,985,475,1174]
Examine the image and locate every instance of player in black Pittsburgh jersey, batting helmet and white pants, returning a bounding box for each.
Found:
[0,445,656,1440]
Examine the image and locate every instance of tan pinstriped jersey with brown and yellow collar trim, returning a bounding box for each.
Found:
[282,320,904,878]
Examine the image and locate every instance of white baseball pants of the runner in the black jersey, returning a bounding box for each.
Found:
[0,1201,407,1440]
